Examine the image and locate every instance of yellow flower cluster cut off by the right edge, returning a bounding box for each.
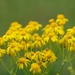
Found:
[59,27,75,51]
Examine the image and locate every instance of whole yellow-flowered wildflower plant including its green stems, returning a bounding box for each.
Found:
[0,14,75,75]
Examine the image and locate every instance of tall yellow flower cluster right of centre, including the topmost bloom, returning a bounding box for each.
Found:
[42,14,68,42]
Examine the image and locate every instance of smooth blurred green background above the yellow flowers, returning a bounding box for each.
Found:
[0,0,75,75]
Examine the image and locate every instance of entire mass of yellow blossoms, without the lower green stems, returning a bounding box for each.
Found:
[0,14,70,74]
